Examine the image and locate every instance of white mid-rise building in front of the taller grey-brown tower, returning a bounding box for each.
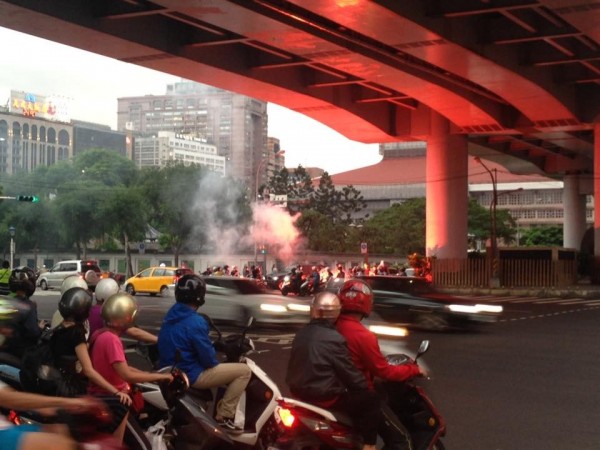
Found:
[133,131,225,175]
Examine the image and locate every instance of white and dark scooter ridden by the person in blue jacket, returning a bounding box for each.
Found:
[138,315,281,449]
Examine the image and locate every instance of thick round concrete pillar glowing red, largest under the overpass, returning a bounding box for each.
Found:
[425,112,469,259]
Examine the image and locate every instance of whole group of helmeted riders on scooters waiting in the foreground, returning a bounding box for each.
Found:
[0,267,445,450]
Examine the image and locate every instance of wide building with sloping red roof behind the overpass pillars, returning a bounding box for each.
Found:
[322,142,593,246]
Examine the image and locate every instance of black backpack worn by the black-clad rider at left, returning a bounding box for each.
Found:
[20,325,62,395]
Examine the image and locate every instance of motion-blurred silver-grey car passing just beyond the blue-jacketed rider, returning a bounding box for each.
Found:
[200,276,311,326]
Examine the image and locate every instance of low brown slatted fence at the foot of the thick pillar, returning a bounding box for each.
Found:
[431,258,577,288]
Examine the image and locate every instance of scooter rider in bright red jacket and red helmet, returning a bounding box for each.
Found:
[336,279,426,449]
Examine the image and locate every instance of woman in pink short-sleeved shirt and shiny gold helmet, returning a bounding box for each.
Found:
[88,292,172,441]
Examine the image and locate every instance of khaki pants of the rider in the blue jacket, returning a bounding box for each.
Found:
[192,363,252,419]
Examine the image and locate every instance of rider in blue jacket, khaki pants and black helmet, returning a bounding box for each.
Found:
[158,274,251,433]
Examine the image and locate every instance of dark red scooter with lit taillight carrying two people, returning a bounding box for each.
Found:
[273,341,446,450]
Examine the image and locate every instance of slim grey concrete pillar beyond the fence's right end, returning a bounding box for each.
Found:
[563,175,586,251]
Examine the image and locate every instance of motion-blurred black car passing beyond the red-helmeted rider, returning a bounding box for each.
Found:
[328,275,502,331]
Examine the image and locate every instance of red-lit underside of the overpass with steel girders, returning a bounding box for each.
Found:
[0,0,600,175]
